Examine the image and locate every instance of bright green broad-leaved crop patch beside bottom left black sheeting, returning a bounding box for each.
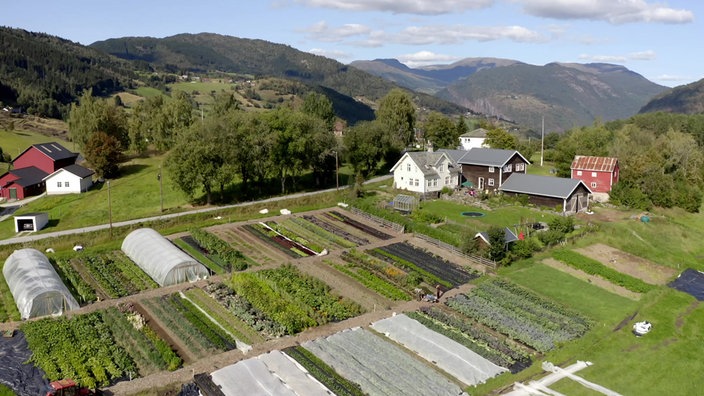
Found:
[21,312,137,388]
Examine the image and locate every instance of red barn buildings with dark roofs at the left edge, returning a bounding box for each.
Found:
[0,142,78,200]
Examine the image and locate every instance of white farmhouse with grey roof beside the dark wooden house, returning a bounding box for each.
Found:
[391,151,460,194]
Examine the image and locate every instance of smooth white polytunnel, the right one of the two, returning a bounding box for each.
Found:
[122,228,208,286]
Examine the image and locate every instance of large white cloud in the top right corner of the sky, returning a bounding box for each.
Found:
[513,0,694,24]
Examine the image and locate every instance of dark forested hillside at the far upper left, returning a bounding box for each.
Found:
[0,27,136,118]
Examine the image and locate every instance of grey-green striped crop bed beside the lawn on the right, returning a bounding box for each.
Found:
[447,281,588,352]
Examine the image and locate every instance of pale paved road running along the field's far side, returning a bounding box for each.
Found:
[0,175,392,245]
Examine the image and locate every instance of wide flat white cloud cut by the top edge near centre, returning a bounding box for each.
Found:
[295,0,494,15]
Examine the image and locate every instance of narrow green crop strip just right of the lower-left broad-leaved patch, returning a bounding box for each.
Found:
[103,307,182,376]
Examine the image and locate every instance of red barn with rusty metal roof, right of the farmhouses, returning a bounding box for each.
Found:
[570,155,619,194]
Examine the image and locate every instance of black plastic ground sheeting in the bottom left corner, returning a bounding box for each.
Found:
[0,332,49,396]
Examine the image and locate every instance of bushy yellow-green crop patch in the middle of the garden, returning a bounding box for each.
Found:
[231,264,362,334]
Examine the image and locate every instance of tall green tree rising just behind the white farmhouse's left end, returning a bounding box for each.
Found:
[376,88,416,149]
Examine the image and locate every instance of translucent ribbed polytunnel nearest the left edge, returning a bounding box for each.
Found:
[2,249,79,319]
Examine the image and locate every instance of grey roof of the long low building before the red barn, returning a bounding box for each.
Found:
[499,173,591,199]
